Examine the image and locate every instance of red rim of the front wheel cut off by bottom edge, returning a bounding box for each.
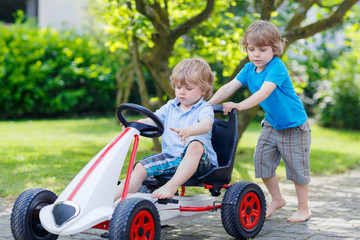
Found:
[130,210,155,240]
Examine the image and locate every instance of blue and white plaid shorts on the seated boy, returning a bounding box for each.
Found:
[139,142,213,177]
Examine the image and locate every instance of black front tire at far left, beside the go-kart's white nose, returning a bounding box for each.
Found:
[10,188,58,240]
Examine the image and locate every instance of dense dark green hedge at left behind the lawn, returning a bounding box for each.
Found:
[0,18,118,119]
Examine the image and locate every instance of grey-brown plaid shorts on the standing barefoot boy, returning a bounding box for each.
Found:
[254,119,311,185]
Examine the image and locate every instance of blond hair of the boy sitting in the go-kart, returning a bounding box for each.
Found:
[170,57,214,100]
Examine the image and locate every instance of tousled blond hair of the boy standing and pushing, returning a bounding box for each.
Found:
[241,20,286,57]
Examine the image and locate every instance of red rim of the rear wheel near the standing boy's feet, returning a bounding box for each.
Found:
[239,192,261,229]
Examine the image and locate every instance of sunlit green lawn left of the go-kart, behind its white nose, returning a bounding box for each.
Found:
[0,118,151,197]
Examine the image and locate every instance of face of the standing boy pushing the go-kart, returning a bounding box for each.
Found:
[246,44,275,72]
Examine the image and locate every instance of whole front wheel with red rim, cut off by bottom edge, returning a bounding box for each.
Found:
[109,198,161,240]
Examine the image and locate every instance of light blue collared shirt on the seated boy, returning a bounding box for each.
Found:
[155,98,218,166]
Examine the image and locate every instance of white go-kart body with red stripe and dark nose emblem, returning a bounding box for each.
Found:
[40,128,215,235]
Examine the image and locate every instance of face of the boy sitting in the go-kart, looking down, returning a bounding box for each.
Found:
[175,82,206,108]
